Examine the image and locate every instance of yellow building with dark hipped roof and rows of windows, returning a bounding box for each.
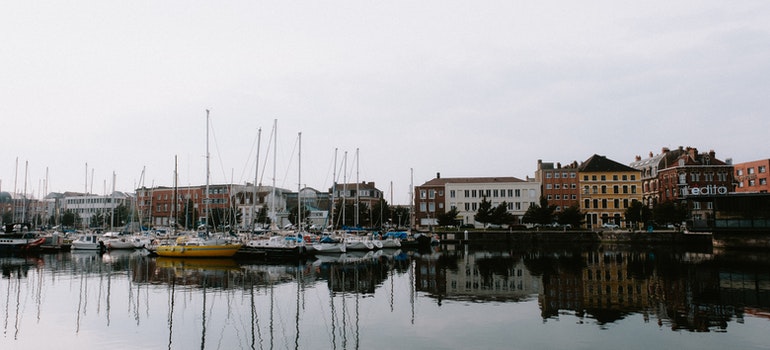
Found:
[578,154,642,228]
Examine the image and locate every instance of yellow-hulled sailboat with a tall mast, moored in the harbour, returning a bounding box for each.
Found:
[155,110,241,258]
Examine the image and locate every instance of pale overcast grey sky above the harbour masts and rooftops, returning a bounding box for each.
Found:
[0,0,770,204]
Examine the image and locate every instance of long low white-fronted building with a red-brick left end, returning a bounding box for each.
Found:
[414,173,541,228]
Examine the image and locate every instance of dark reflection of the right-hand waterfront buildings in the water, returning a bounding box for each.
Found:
[414,243,770,332]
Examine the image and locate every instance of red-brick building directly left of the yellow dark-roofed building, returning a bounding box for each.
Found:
[535,159,580,213]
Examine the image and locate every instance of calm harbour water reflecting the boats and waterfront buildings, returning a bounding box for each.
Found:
[0,246,770,349]
